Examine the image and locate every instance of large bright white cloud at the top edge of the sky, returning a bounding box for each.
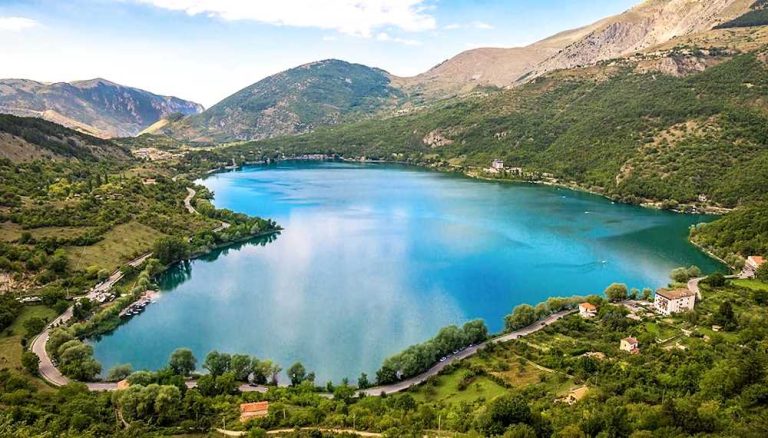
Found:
[134,0,436,37]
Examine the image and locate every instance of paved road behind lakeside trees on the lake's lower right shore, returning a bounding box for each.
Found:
[358,309,576,396]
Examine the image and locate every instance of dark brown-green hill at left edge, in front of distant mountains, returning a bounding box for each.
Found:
[0,114,131,162]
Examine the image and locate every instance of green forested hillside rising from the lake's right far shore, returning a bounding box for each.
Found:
[246,54,768,207]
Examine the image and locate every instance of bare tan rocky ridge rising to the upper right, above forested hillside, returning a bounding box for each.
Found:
[398,0,754,100]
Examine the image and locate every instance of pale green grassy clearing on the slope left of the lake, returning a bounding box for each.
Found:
[67,221,162,272]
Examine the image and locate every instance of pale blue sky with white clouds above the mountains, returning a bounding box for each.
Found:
[0,0,639,107]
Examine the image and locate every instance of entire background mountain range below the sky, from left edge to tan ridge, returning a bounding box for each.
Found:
[0,0,766,142]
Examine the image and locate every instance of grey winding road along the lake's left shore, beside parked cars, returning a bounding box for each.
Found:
[31,252,152,388]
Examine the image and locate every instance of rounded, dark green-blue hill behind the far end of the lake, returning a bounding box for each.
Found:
[153,60,403,141]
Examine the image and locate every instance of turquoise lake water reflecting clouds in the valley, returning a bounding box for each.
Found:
[94,162,719,383]
